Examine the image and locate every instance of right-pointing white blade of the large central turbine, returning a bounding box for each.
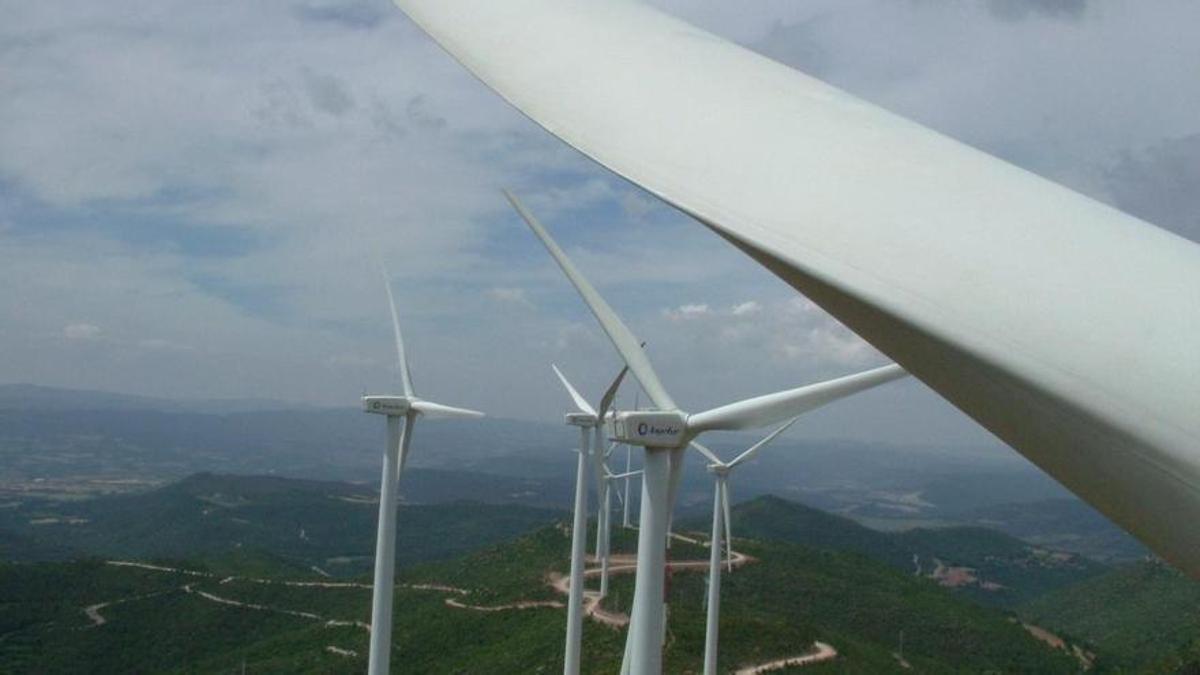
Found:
[688,364,908,434]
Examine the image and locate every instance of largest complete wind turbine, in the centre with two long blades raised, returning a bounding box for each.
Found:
[504,191,906,675]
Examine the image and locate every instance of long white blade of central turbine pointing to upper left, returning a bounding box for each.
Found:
[504,190,677,410]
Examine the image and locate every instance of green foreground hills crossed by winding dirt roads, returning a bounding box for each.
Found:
[0,526,1078,673]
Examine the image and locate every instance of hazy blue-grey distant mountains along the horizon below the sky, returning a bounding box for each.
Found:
[0,384,1142,562]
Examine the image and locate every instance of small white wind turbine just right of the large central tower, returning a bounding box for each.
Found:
[691,403,882,675]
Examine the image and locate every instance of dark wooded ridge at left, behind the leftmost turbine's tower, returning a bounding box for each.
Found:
[0,472,562,574]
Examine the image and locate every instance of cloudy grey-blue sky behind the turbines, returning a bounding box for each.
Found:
[0,0,1200,444]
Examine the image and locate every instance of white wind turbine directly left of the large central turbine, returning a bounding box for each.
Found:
[551,364,629,675]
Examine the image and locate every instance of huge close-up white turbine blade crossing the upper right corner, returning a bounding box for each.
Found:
[395,0,1200,577]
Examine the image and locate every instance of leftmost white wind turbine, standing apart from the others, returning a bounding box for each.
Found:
[362,271,484,675]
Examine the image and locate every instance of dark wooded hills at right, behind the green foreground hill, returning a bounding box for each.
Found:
[689,496,1106,607]
